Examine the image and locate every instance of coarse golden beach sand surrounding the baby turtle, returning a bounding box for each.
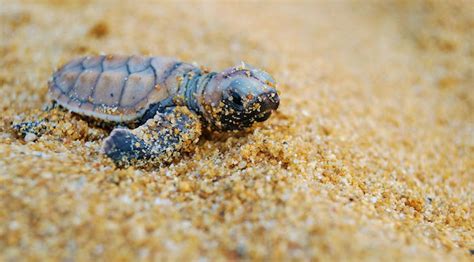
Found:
[0,0,474,261]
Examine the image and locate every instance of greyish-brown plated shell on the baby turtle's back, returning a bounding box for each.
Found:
[49,55,180,122]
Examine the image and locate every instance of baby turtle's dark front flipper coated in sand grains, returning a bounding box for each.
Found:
[103,107,201,167]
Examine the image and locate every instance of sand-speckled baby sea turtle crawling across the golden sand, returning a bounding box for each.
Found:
[14,55,280,167]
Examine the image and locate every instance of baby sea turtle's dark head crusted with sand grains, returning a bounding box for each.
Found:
[199,63,280,131]
